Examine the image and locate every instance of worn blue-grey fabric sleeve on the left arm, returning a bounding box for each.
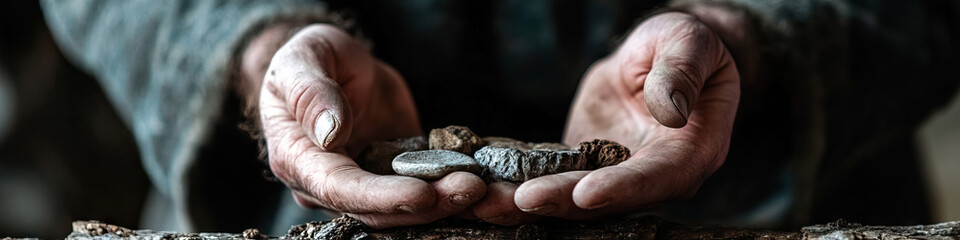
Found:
[41,0,325,199]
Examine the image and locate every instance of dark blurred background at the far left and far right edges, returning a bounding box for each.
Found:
[0,1,960,238]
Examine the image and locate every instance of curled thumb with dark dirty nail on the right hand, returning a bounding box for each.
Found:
[618,13,732,128]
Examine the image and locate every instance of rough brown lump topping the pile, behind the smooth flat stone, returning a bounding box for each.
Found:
[430,126,483,155]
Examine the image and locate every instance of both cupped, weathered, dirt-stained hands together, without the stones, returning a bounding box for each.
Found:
[240,10,740,228]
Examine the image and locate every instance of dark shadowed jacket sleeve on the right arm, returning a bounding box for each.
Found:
[671,0,960,227]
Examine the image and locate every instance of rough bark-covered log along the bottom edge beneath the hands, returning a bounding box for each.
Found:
[67,217,960,240]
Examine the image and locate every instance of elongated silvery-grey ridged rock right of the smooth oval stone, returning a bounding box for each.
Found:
[474,146,586,182]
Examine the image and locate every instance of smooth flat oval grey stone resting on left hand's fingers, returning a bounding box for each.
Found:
[393,150,482,180]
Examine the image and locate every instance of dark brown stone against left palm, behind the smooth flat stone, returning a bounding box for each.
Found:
[357,136,429,175]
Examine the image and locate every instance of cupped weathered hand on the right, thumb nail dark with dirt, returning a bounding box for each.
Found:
[474,13,740,224]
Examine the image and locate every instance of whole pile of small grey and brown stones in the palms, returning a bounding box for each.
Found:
[357,126,630,183]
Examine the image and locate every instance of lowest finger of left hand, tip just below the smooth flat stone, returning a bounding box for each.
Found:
[349,172,486,228]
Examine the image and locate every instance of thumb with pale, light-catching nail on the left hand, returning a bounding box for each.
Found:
[264,25,375,150]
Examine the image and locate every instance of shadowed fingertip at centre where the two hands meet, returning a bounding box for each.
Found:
[473,182,539,226]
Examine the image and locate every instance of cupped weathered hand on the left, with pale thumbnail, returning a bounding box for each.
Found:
[244,24,486,228]
